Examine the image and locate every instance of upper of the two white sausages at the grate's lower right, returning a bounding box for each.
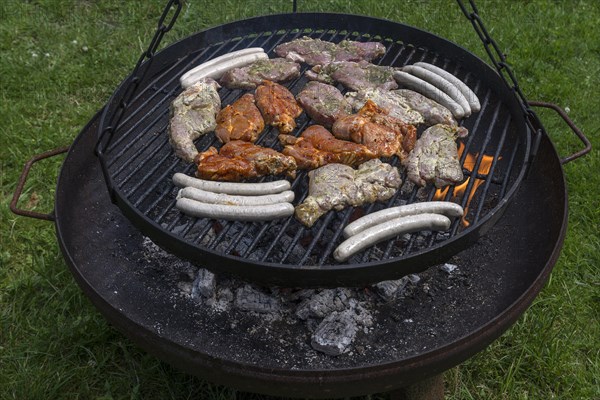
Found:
[343,201,464,238]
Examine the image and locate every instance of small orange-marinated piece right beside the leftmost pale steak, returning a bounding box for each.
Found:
[215,93,265,143]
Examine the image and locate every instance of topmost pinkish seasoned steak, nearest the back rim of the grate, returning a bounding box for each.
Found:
[275,36,386,66]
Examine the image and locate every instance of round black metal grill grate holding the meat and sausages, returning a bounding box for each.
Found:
[95,12,527,284]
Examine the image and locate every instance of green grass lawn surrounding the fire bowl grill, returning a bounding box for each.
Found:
[0,0,600,400]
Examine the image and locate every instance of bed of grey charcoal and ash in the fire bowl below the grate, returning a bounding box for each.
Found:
[143,238,457,356]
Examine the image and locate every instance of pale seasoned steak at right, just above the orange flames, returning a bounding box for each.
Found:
[406,124,464,188]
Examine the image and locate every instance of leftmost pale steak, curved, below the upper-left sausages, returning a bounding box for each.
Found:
[169,79,221,162]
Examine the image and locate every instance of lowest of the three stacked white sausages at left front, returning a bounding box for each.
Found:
[175,198,294,221]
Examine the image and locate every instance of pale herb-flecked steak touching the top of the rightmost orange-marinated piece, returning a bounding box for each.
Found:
[346,88,424,125]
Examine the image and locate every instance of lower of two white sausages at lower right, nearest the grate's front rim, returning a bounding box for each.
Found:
[333,213,451,261]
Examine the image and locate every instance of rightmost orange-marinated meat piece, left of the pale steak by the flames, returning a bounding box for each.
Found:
[332,100,417,162]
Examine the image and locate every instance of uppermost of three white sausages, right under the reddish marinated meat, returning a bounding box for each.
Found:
[173,172,292,196]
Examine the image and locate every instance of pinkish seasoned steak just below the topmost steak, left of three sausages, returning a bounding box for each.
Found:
[305,61,398,91]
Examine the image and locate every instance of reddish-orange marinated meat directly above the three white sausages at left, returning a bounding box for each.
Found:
[196,140,296,182]
